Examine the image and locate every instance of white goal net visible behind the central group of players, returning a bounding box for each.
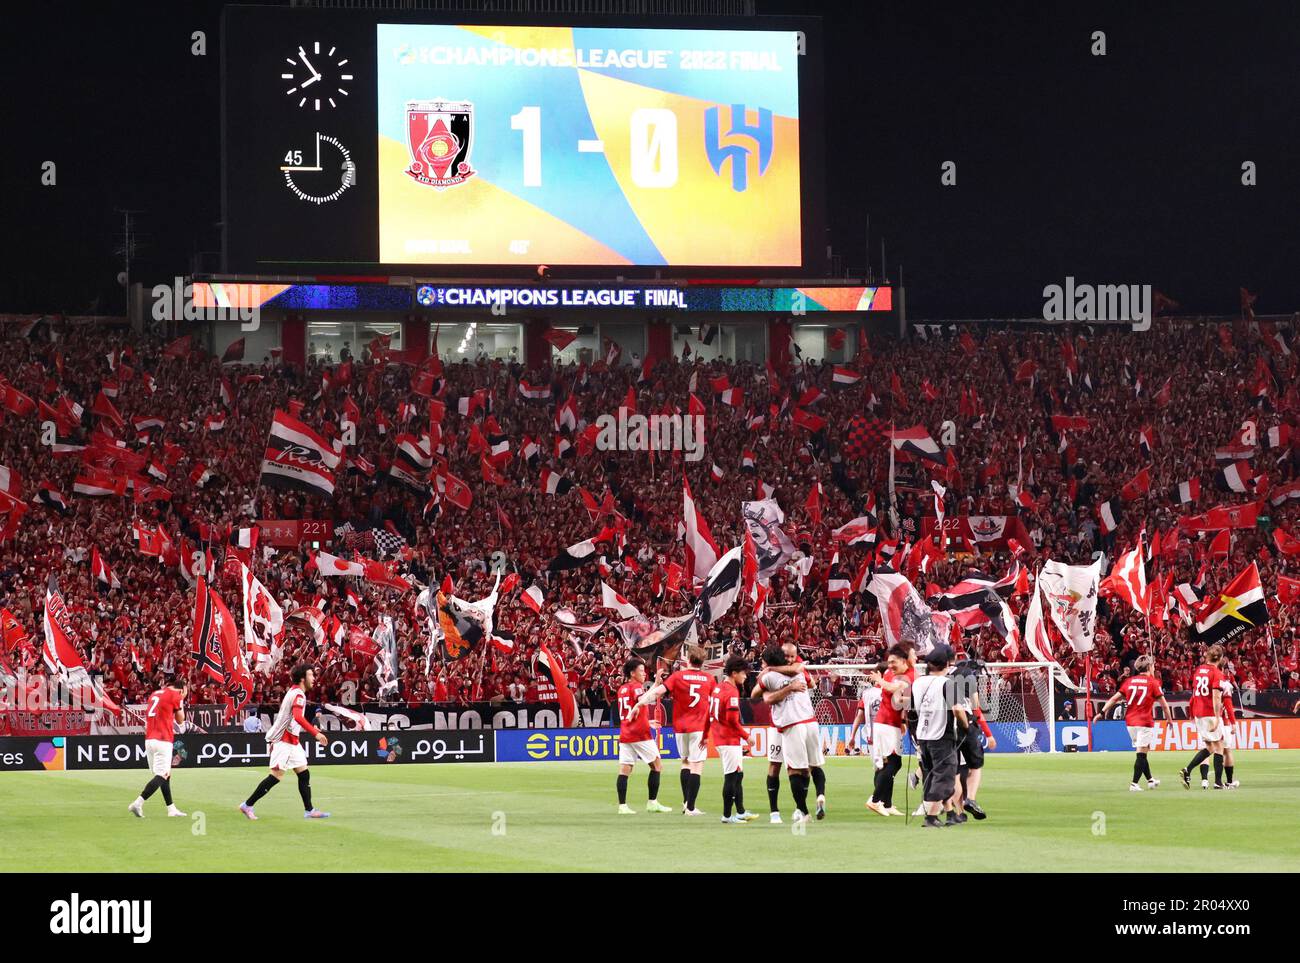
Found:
[807,661,1057,752]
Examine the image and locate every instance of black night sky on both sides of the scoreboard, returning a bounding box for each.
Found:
[0,0,1300,318]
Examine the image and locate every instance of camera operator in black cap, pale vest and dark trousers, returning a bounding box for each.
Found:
[911,643,969,829]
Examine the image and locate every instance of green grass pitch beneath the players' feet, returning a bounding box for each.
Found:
[0,750,1300,872]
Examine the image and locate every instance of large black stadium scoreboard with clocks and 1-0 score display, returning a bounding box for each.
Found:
[222,6,824,273]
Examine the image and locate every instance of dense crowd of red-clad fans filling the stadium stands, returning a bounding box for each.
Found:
[0,311,1300,722]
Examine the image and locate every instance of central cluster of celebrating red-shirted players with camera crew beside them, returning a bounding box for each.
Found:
[618,642,997,827]
